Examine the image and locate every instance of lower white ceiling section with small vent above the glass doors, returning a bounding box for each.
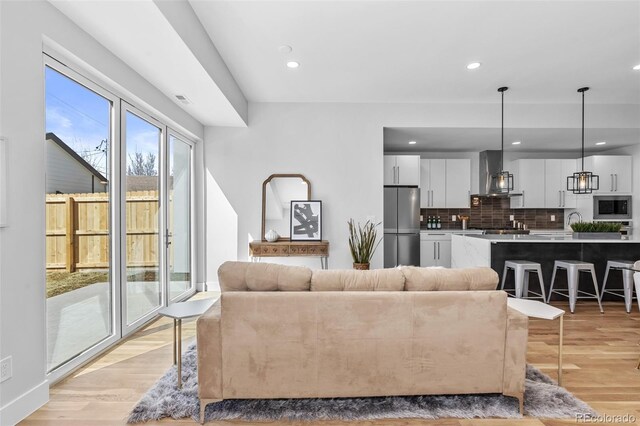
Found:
[49,0,245,126]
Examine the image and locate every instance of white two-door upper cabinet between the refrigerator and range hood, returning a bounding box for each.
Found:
[420,158,471,209]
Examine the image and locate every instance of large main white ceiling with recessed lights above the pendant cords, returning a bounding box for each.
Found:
[189,0,640,104]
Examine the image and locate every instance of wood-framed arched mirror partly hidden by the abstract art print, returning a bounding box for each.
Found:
[260,174,311,241]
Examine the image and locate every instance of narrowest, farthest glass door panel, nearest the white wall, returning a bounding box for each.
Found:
[166,132,194,301]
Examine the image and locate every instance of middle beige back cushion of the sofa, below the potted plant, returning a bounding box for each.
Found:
[311,269,404,291]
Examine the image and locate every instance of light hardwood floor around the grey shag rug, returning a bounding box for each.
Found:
[20,294,640,426]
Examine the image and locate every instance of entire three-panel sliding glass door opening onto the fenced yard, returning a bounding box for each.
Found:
[44,55,195,381]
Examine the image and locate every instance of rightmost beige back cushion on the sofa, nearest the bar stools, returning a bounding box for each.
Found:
[399,266,498,291]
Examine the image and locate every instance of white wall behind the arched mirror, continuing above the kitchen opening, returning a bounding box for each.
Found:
[205,103,640,281]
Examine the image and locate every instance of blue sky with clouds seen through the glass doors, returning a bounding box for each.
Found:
[45,67,159,173]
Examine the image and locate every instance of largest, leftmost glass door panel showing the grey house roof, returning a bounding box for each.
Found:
[44,61,119,380]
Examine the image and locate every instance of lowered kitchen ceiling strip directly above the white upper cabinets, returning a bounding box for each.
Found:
[384,127,640,154]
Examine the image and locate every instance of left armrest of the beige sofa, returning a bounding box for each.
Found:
[196,299,222,399]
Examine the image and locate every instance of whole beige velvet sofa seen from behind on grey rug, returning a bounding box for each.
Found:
[197,262,527,419]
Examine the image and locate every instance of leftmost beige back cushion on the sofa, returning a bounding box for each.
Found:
[218,262,311,292]
